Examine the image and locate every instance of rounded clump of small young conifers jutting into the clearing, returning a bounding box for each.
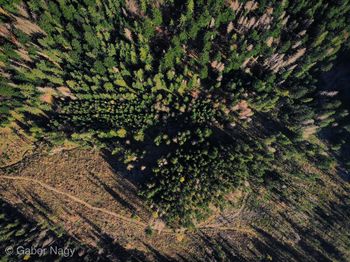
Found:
[143,140,247,226]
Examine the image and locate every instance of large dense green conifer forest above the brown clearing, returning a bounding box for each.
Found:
[0,0,350,226]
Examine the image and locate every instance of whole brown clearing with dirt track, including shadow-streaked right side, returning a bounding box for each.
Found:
[0,126,350,261]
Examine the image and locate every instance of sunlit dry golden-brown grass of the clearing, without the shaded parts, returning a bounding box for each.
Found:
[0,129,348,261]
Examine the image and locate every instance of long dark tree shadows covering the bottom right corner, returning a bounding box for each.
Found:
[253,188,350,261]
